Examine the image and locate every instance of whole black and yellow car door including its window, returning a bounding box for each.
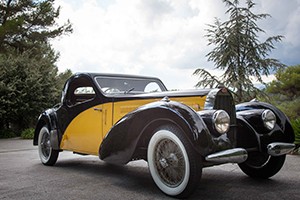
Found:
[60,76,103,155]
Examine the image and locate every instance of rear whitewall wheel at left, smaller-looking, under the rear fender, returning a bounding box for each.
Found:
[38,126,59,166]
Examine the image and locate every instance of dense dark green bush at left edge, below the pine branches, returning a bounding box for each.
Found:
[0,45,58,130]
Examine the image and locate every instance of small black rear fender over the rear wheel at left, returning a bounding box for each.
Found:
[33,108,60,150]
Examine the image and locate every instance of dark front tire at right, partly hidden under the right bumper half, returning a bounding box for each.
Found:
[239,152,285,179]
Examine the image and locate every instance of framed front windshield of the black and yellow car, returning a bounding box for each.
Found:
[96,76,166,94]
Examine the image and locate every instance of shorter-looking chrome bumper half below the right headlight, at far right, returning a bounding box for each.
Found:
[267,142,295,156]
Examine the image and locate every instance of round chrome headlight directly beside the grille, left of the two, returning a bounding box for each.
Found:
[213,110,230,134]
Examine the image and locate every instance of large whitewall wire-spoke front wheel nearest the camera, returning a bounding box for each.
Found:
[147,125,202,198]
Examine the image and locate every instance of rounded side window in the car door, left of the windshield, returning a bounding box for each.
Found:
[66,77,96,106]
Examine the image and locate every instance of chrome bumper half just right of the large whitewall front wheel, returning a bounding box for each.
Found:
[205,148,248,164]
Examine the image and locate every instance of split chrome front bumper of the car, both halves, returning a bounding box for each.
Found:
[205,142,295,164]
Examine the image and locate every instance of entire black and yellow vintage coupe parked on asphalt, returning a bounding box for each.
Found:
[33,73,295,198]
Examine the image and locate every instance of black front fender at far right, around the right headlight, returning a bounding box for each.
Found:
[236,101,295,151]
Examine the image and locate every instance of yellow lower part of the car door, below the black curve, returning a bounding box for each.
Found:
[60,105,103,155]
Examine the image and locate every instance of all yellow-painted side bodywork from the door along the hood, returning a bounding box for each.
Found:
[60,96,206,155]
